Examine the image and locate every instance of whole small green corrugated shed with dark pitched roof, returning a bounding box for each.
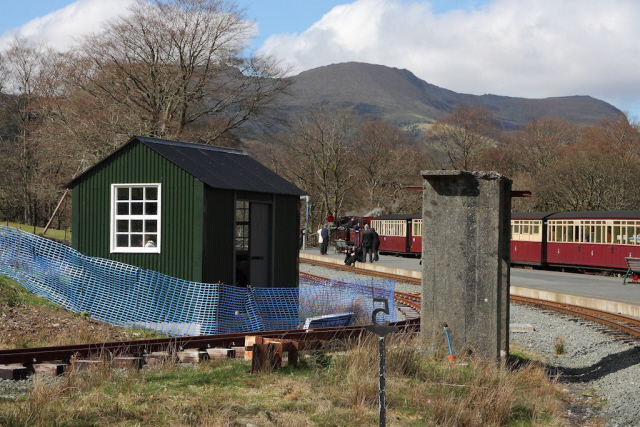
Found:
[67,136,306,287]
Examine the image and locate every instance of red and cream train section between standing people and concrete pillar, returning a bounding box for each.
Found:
[371,214,422,256]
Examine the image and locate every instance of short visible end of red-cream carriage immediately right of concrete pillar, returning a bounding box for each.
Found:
[511,212,553,266]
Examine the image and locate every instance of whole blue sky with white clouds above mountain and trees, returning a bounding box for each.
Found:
[0,0,640,121]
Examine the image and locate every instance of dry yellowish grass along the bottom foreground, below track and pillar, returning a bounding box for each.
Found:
[0,335,563,427]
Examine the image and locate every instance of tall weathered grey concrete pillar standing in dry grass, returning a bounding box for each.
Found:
[421,170,511,358]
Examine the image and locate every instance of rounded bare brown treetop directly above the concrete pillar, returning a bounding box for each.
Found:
[428,105,499,170]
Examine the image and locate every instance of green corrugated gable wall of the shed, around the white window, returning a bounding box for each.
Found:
[72,143,204,282]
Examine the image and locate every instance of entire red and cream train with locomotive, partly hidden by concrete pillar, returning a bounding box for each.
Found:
[335,210,640,272]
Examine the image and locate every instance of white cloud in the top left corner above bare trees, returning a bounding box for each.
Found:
[0,0,135,50]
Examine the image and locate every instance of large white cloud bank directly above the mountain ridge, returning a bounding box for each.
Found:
[260,0,640,114]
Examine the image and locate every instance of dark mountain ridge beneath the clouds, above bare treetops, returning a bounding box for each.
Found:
[285,62,622,129]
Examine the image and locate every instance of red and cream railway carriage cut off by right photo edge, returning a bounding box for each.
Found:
[546,210,640,271]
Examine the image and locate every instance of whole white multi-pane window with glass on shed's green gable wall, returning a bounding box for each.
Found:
[111,184,160,253]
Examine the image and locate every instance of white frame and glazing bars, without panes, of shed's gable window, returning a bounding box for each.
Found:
[109,183,162,253]
